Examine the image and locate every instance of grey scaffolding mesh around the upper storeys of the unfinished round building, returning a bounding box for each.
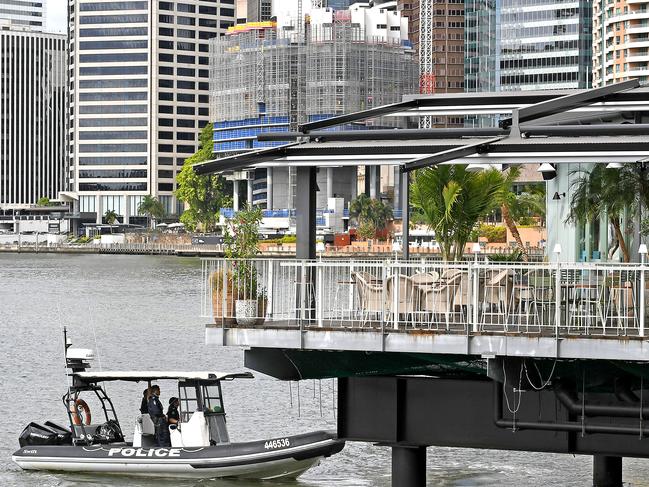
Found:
[210,17,417,127]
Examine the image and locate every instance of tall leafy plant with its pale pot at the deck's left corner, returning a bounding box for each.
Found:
[223,205,267,326]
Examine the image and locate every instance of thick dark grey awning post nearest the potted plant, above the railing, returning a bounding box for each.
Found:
[295,167,316,259]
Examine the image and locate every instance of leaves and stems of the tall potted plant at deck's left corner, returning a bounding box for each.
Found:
[223,205,263,299]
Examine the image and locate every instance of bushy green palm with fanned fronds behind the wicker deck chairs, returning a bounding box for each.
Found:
[410,164,503,260]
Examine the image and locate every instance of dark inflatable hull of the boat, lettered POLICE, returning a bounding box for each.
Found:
[12,432,345,480]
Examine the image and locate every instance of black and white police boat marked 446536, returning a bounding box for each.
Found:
[12,339,345,480]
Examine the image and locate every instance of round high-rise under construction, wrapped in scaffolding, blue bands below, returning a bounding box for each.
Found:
[210,5,417,208]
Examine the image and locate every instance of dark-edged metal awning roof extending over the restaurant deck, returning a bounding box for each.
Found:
[195,80,649,174]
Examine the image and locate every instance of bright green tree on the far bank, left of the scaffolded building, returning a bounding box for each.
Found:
[175,123,230,232]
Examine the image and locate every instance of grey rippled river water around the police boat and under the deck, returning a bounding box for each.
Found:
[0,254,649,487]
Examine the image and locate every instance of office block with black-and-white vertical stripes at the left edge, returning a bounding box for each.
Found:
[0,26,67,208]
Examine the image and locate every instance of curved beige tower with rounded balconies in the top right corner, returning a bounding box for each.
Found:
[593,0,649,88]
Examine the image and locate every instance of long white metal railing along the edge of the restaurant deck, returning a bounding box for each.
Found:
[201,258,649,337]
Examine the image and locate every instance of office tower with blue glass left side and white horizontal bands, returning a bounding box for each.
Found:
[465,0,592,92]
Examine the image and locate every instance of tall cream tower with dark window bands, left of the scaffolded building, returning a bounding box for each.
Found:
[69,0,235,223]
